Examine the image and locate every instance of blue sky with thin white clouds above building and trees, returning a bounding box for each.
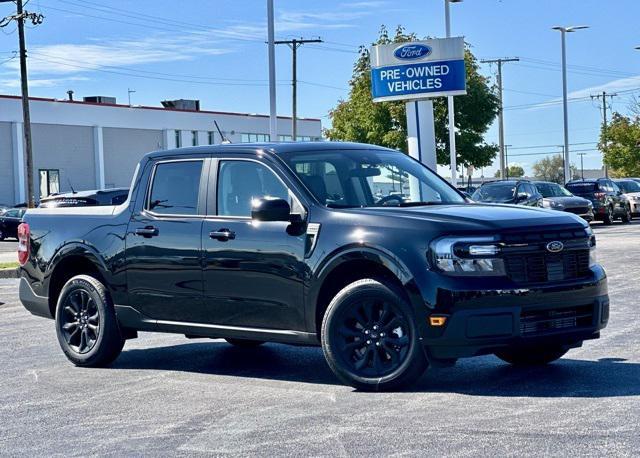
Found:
[0,0,640,176]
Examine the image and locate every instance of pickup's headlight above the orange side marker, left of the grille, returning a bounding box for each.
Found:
[429,237,505,276]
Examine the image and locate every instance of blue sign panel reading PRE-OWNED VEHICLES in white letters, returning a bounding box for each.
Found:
[371,59,466,101]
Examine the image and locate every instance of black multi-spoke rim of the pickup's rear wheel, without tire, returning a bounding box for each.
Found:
[61,289,100,354]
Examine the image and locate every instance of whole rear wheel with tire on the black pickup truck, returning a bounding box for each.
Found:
[56,275,124,367]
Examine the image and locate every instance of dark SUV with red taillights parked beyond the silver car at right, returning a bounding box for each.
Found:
[566,178,631,224]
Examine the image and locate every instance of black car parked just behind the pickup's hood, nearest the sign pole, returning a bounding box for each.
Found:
[471,180,542,207]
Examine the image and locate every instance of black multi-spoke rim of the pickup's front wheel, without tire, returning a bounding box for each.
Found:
[333,300,411,377]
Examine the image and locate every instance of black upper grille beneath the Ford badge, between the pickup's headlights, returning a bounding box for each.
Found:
[504,249,589,283]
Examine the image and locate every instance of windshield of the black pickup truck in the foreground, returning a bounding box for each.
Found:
[280,149,465,208]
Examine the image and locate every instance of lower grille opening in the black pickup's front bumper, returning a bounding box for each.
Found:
[520,305,593,335]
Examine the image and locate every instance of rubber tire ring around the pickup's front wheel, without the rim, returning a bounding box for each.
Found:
[321,280,426,390]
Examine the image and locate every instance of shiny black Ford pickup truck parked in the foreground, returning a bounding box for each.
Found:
[18,142,609,390]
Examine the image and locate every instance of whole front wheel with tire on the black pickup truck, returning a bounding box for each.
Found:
[321,279,428,391]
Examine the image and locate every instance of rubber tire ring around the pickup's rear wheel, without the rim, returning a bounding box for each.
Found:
[55,275,111,365]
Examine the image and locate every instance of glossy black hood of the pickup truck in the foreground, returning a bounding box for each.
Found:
[346,204,586,231]
